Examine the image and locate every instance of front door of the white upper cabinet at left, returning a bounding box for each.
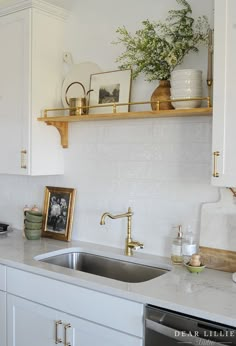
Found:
[0,9,29,173]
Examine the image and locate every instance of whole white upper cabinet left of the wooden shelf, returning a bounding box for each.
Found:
[0,0,66,175]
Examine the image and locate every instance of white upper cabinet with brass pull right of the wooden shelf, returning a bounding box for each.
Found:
[212,0,236,187]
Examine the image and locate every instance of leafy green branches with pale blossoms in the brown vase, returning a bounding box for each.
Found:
[113,0,209,109]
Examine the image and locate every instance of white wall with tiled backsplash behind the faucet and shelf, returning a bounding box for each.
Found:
[0,0,218,256]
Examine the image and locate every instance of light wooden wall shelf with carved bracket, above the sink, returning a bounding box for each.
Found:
[38,107,212,148]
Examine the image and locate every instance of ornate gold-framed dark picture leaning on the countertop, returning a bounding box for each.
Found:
[42,186,76,241]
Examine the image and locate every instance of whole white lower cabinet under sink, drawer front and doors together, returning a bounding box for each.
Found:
[6,267,144,346]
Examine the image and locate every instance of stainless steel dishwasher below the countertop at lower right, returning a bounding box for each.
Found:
[145,305,236,346]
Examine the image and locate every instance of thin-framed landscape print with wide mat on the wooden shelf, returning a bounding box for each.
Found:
[89,69,132,114]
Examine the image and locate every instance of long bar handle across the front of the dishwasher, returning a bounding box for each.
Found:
[146,319,225,346]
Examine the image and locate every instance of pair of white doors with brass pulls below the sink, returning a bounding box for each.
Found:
[7,294,142,346]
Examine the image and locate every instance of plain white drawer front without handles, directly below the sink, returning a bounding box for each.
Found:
[7,268,143,337]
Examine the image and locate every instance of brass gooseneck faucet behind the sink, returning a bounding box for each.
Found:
[100,207,143,256]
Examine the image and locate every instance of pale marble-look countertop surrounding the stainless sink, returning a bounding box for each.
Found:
[0,230,236,327]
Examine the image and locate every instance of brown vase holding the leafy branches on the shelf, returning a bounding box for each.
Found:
[151,80,173,111]
